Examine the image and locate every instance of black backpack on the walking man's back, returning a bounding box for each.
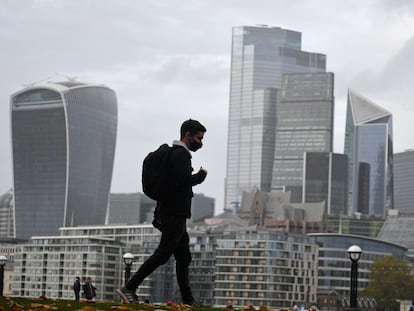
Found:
[142,144,172,201]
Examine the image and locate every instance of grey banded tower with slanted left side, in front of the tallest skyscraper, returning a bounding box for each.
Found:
[272,72,334,202]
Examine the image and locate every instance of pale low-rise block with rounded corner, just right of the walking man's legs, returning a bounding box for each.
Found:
[214,230,318,307]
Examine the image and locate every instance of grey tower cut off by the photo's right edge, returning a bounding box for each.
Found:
[393,150,414,215]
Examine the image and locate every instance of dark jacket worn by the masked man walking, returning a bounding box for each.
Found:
[158,145,206,218]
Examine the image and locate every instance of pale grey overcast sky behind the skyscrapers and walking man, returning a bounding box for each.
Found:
[0,0,414,213]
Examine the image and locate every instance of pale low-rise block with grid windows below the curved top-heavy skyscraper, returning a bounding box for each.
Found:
[11,236,124,300]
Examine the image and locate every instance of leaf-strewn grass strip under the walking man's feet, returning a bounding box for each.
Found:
[0,297,224,311]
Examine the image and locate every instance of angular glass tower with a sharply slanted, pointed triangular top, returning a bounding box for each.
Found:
[344,90,394,216]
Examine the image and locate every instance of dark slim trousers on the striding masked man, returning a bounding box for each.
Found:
[125,214,194,304]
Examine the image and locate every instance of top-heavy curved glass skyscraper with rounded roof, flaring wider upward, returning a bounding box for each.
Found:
[10,81,117,238]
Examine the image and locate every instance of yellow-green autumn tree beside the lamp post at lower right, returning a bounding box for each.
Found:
[361,256,414,310]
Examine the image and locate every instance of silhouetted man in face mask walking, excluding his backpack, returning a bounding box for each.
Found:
[117,119,207,305]
